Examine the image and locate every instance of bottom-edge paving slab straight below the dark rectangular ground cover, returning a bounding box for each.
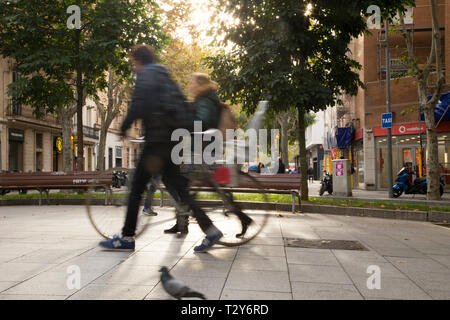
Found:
[291,281,363,300]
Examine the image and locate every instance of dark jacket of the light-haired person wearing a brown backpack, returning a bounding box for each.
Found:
[192,90,220,131]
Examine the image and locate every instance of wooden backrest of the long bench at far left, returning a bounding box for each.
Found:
[0,171,113,188]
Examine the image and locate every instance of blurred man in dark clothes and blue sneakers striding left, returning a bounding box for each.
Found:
[100,45,223,252]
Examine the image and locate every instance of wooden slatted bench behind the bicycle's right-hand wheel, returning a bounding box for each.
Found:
[160,173,301,213]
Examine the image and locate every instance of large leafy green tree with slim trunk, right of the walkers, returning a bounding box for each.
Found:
[207,0,412,200]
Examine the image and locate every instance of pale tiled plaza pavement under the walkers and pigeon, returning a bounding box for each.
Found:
[0,206,450,300]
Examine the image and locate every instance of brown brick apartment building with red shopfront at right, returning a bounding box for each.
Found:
[324,0,450,190]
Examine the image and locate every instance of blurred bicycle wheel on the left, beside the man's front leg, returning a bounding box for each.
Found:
[86,168,151,239]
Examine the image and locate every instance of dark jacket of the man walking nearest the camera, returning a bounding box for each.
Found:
[121,64,178,143]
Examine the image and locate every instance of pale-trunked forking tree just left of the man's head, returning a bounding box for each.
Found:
[95,68,131,171]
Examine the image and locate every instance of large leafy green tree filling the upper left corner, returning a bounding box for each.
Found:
[0,0,166,170]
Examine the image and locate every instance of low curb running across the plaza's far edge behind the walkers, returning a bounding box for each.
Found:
[0,199,450,223]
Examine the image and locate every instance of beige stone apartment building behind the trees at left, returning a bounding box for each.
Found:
[0,57,142,172]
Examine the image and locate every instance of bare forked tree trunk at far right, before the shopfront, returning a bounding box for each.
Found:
[398,0,445,200]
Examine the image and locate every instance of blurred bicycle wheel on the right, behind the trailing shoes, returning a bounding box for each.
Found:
[191,172,269,247]
